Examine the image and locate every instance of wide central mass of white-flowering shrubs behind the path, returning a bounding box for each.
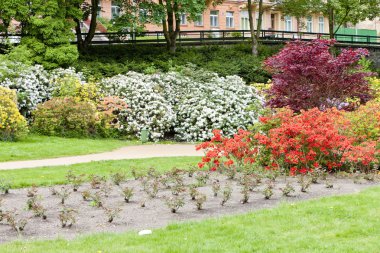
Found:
[102,68,262,141]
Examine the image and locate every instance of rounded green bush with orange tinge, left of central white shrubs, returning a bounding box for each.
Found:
[32,97,100,138]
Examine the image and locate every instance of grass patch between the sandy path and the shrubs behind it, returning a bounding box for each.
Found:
[0,135,141,162]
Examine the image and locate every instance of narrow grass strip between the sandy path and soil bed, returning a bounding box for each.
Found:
[0,157,200,189]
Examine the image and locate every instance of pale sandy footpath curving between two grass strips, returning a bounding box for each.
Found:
[0,144,203,170]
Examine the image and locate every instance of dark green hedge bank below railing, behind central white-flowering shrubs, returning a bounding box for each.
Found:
[74,44,280,83]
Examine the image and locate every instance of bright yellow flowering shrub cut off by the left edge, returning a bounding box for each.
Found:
[0,87,28,141]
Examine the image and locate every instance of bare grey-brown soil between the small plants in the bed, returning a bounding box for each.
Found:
[0,173,377,243]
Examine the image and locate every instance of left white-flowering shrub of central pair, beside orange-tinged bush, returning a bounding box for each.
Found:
[102,72,176,140]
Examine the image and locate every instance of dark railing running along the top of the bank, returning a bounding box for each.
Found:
[0,30,380,45]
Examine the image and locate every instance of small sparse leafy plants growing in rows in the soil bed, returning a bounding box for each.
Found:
[0,167,379,233]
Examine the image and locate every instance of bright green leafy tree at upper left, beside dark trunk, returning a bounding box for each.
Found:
[6,0,82,69]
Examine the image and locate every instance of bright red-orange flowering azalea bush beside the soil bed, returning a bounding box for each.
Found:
[197,108,377,174]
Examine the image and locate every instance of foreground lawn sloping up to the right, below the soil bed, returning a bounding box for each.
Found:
[0,187,380,253]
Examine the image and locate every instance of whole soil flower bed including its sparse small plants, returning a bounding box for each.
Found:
[0,170,378,243]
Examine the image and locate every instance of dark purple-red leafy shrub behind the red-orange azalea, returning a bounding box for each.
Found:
[265,40,373,112]
